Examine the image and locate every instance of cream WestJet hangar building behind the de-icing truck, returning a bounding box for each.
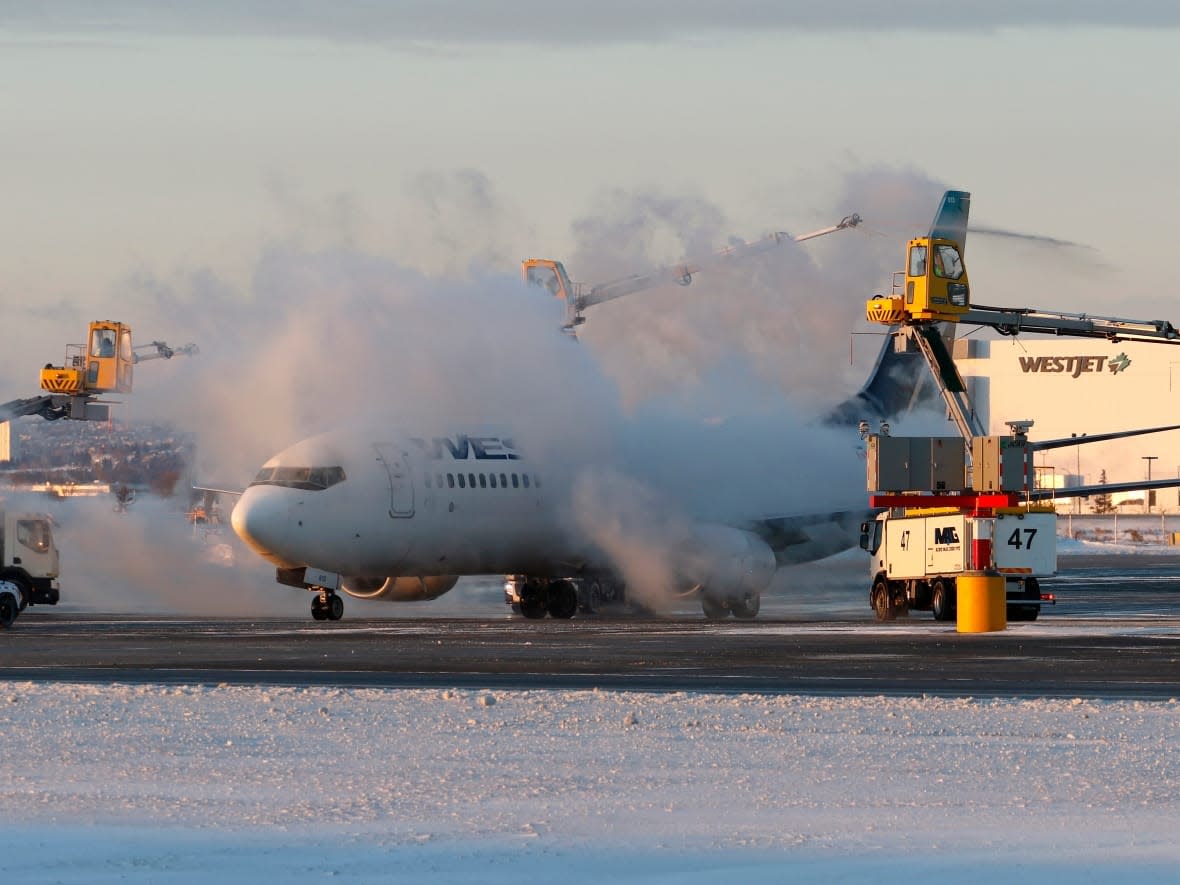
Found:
[955,336,1180,500]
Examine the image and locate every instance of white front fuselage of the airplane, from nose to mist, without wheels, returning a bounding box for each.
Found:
[232,433,589,577]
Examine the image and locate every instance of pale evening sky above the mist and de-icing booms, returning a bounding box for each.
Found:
[0,0,1180,399]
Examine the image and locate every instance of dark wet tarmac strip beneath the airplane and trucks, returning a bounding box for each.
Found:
[0,557,1180,699]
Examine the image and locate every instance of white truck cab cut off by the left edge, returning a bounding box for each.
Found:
[0,511,61,627]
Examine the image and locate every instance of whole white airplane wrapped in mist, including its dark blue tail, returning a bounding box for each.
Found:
[231,219,937,621]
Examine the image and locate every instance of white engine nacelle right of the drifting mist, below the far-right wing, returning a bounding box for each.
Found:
[676,525,778,597]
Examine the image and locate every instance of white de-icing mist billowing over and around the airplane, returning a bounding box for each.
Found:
[11,171,958,614]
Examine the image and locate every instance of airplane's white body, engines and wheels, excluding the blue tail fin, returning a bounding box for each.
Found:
[231,417,887,620]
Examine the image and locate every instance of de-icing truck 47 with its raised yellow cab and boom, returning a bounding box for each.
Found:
[860,191,1180,621]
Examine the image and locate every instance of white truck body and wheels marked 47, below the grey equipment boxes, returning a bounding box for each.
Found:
[860,509,1057,621]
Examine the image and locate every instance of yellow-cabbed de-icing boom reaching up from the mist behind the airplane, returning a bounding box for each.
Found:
[520,214,861,333]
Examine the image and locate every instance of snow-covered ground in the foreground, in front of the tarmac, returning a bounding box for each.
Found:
[0,682,1180,885]
